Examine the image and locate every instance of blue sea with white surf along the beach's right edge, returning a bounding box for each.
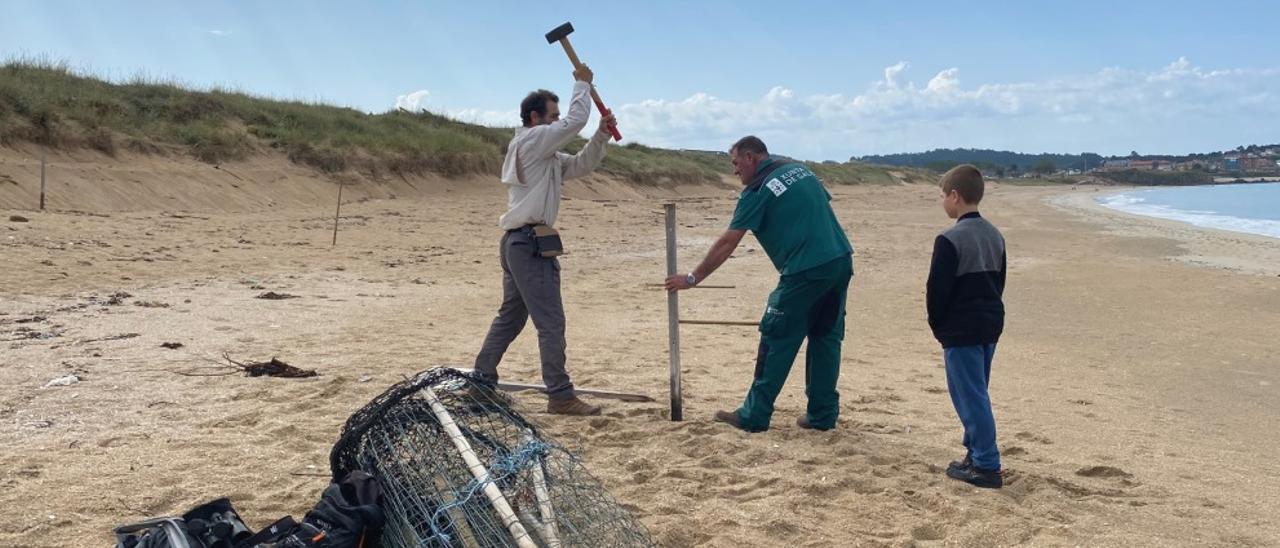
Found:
[1097,183,1280,238]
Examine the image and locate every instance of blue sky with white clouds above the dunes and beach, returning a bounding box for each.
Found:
[0,0,1280,161]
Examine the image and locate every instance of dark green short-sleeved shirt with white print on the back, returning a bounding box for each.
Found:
[728,157,854,275]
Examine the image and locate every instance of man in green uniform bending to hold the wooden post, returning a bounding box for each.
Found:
[666,136,854,431]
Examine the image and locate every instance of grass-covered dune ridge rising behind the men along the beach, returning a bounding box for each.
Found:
[0,60,925,184]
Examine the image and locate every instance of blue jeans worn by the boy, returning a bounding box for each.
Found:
[942,344,1000,470]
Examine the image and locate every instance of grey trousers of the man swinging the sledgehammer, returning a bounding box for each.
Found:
[475,227,573,399]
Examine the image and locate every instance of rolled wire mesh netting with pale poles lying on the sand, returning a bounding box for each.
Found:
[330,367,655,548]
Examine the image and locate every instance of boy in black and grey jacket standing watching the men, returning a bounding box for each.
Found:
[925,164,1009,489]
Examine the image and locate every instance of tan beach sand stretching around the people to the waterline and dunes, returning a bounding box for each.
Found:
[0,151,1280,547]
